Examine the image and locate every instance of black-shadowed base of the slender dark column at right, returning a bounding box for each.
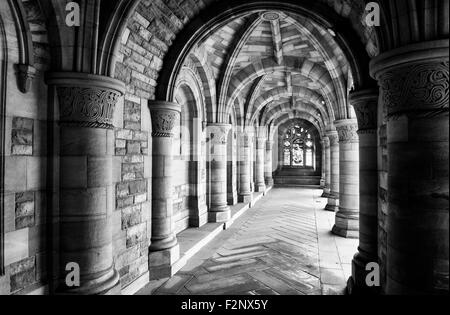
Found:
[347,253,380,295]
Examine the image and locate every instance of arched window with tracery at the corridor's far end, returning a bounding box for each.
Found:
[283,124,314,167]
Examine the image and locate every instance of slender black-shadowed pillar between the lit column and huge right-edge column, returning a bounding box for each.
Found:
[348,89,379,294]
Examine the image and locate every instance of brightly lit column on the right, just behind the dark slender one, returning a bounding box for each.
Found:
[333,119,359,238]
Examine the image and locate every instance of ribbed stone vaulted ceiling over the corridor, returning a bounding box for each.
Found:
[179,11,362,134]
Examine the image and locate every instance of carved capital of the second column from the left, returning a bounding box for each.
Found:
[148,101,181,138]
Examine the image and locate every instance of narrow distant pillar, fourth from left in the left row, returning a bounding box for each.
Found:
[239,132,253,203]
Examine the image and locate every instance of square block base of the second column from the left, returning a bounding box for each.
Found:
[148,244,180,280]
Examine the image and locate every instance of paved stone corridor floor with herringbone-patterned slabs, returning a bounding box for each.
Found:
[138,188,358,295]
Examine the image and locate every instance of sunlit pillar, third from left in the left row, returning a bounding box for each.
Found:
[207,124,231,222]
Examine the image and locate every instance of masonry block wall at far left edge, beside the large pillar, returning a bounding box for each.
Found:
[0,0,53,294]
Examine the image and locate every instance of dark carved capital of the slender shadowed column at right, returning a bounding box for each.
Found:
[349,88,379,134]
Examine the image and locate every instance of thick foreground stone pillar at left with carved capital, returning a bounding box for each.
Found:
[47,72,125,295]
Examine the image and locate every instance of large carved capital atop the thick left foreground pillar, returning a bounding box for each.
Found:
[46,72,125,129]
